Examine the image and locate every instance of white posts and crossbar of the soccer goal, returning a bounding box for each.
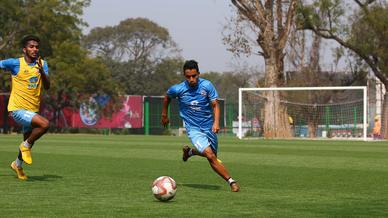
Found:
[237,86,368,141]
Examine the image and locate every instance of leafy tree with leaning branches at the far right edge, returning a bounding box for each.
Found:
[298,0,388,138]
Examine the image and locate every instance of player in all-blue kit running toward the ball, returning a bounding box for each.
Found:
[162,60,240,192]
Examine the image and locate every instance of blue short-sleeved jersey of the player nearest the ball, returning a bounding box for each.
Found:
[167,78,218,130]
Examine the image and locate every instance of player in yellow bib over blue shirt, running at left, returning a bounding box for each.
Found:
[0,35,50,180]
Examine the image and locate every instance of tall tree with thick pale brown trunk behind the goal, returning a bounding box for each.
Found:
[225,0,297,137]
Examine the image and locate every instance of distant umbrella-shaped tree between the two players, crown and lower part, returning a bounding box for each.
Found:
[83,18,179,94]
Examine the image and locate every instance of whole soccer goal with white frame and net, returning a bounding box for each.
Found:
[237,86,367,141]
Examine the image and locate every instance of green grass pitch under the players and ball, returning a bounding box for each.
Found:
[0,134,388,217]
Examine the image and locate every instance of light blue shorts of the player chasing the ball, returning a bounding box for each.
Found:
[187,128,218,154]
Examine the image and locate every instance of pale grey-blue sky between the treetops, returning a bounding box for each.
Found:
[83,0,260,72]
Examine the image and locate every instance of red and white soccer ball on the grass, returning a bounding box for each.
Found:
[152,176,176,201]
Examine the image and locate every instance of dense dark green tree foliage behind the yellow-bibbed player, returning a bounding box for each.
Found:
[0,0,120,122]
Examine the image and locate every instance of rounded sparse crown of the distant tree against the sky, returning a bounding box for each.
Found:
[83,18,175,61]
